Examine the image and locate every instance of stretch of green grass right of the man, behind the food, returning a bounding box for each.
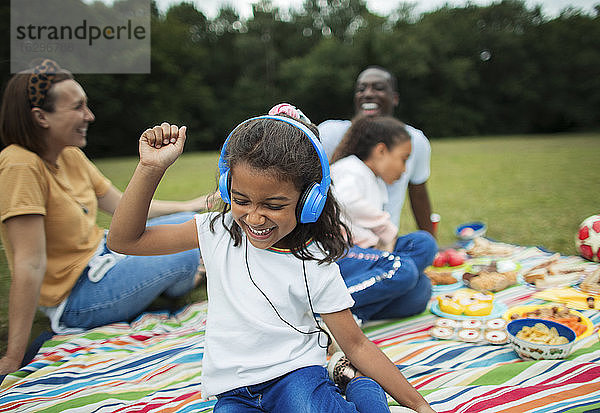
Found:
[400,134,600,255]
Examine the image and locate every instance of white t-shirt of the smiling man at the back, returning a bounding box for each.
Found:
[319,120,431,225]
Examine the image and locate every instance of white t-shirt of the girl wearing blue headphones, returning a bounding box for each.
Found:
[196,213,354,396]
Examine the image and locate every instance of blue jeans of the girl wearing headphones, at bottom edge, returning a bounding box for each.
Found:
[214,366,390,413]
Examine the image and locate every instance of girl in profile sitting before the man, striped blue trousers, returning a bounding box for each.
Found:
[331,116,437,321]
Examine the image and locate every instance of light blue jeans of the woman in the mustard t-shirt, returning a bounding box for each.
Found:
[61,212,200,328]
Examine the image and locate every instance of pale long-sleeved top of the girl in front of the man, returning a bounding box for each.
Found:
[331,155,398,248]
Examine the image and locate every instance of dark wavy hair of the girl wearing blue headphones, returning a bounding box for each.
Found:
[210,115,352,264]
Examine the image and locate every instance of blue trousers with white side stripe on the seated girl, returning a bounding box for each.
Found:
[337,231,437,321]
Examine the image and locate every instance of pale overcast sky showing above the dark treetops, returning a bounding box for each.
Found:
[149,0,600,18]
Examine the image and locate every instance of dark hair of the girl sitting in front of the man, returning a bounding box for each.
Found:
[331,116,410,163]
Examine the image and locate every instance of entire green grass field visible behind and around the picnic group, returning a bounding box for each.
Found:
[0,134,600,354]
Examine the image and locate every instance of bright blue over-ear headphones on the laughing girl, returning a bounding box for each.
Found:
[218,115,331,224]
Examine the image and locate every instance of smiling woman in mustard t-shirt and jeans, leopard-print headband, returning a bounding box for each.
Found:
[0,59,207,375]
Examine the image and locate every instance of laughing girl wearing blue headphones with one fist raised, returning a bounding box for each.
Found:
[108,104,433,413]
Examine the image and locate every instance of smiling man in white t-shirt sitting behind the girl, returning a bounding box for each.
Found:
[319,66,435,235]
